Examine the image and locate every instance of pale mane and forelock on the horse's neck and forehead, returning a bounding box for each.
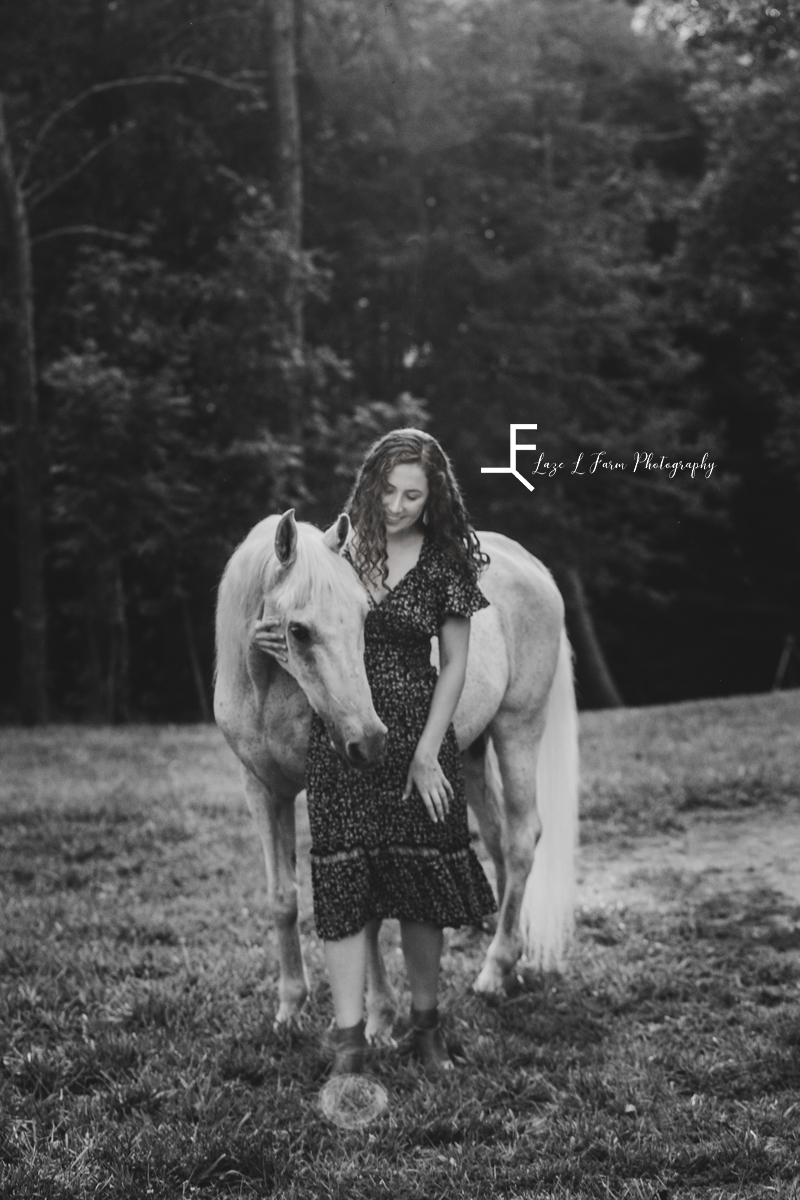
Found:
[216,516,356,696]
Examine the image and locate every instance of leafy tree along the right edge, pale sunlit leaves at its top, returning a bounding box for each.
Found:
[650,0,800,686]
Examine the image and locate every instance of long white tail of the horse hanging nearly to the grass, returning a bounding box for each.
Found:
[496,630,578,971]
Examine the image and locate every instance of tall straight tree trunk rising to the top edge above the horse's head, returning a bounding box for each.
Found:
[270,0,305,439]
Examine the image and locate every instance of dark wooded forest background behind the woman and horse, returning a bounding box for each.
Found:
[0,0,800,721]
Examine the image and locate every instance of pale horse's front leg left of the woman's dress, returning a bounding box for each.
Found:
[243,767,308,1028]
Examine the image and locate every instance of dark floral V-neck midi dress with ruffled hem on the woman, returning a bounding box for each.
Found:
[306,535,497,941]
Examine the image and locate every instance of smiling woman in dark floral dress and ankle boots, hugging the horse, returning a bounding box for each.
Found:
[257,430,495,1074]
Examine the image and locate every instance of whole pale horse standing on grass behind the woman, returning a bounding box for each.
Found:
[213,509,578,1044]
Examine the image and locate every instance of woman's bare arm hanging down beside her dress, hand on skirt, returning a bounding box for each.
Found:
[403,617,469,821]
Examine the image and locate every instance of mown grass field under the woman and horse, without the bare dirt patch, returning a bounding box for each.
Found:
[0,692,800,1200]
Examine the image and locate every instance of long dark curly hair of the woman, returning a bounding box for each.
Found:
[345,430,489,587]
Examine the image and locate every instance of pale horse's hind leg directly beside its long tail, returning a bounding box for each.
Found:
[475,716,542,994]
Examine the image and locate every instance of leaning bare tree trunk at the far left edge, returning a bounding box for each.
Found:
[0,96,47,725]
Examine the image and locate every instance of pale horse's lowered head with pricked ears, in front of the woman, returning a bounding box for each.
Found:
[264,509,386,767]
